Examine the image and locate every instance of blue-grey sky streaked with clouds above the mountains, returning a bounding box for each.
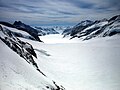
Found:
[0,0,120,26]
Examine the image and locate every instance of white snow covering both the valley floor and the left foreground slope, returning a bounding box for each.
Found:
[0,30,120,90]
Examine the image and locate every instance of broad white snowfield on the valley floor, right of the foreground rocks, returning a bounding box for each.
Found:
[22,35,120,90]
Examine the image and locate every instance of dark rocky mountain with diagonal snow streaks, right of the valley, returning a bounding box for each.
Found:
[62,15,120,40]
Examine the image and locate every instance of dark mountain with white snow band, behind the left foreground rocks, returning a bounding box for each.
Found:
[0,21,42,42]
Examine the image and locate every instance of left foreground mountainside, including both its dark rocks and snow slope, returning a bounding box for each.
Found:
[0,25,65,90]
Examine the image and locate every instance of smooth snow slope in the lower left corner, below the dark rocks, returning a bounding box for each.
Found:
[0,40,55,90]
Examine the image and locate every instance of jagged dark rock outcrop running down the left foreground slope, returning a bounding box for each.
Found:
[0,26,46,76]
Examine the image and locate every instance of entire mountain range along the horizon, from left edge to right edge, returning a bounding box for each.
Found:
[0,15,120,42]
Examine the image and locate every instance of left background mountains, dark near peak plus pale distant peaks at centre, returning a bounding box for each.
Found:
[0,21,63,42]
